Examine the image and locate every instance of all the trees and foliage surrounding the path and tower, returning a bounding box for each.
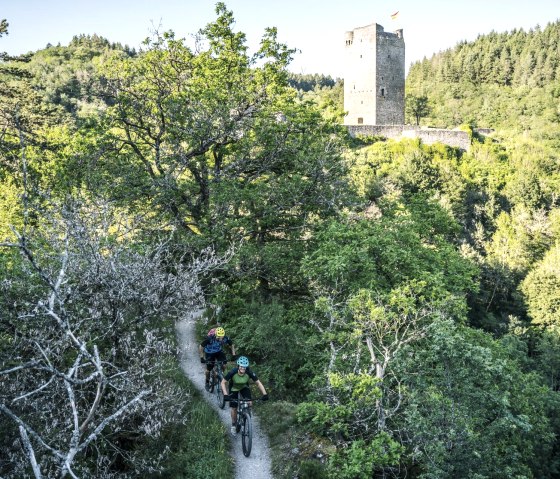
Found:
[0,3,560,479]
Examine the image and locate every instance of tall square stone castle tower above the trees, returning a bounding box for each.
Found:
[344,23,405,125]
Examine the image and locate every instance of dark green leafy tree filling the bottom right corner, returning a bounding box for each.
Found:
[395,319,554,479]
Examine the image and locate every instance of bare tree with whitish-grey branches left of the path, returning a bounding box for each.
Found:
[0,204,230,478]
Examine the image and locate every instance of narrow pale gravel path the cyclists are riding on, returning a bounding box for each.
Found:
[177,312,273,479]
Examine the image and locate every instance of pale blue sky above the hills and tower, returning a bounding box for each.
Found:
[0,0,560,77]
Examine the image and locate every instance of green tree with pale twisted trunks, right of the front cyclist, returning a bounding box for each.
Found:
[300,197,476,477]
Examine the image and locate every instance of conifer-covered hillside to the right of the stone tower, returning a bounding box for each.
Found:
[406,21,560,142]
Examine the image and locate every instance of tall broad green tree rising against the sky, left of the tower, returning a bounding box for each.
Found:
[98,3,346,297]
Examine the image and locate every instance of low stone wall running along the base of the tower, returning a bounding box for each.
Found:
[347,125,471,151]
